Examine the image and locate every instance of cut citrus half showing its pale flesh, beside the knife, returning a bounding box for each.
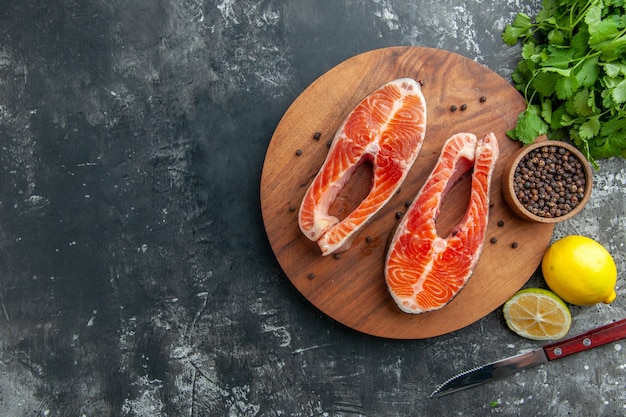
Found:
[502,288,572,340]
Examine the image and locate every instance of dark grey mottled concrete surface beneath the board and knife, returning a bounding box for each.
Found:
[0,0,626,417]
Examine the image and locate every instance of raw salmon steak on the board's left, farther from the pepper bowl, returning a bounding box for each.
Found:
[298,78,426,255]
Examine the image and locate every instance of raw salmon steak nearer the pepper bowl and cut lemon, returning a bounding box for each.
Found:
[385,133,498,314]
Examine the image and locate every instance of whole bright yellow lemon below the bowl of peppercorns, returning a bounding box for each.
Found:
[541,235,617,306]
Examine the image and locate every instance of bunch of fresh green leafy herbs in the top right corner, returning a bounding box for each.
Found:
[502,0,626,168]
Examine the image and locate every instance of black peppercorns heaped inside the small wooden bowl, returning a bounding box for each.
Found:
[513,145,586,218]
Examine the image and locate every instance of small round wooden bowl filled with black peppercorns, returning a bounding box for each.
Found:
[502,137,593,223]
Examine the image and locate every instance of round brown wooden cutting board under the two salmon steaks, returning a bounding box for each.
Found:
[261,47,554,339]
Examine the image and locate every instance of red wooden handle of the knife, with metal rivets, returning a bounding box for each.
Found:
[543,319,626,361]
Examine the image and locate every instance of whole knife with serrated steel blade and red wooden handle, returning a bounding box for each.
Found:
[430,318,626,398]
